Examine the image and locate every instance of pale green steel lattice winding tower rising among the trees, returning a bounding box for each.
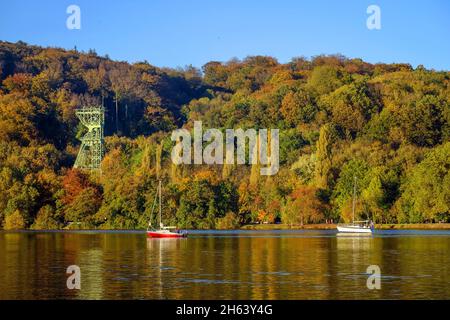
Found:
[74,106,105,170]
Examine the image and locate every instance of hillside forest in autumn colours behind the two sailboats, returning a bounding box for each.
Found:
[0,42,450,229]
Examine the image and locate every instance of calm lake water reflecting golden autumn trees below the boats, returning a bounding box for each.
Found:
[0,231,450,299]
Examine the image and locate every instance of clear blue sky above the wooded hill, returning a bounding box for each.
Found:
[0,0,450,70]
